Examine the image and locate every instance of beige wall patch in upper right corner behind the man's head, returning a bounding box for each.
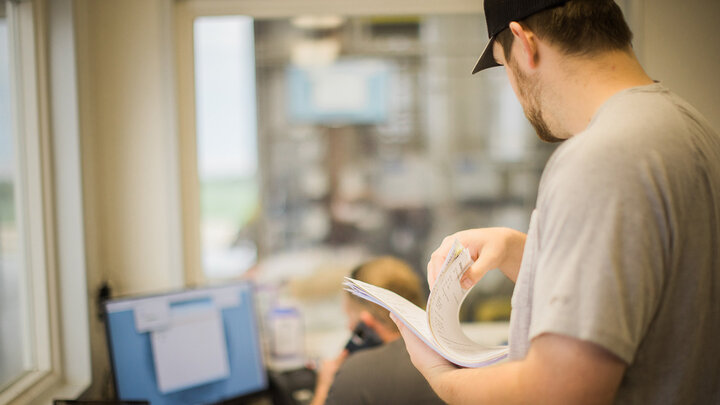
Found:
[636,0,720,131]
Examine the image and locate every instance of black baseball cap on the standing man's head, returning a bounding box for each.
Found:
[473,0,568,74]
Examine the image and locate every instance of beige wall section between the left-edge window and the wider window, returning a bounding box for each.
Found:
[74,0,183,397]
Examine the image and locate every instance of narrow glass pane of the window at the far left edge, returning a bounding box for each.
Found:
[0,2,32,390]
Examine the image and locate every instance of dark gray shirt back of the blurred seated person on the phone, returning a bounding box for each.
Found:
[325,339,444,405]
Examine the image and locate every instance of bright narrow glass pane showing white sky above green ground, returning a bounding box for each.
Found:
[194,16,259,278]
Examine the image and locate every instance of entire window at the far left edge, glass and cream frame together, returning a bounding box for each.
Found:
[0,0,90,404]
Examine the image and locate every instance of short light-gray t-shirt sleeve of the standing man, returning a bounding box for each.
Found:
[529,145,670,363]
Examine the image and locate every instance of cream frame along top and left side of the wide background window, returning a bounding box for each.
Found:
[173,0,483,285]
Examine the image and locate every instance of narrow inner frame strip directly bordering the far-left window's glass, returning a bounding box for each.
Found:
[0,1,59,402]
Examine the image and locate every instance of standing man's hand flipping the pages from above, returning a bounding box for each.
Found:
[427,228,527,289]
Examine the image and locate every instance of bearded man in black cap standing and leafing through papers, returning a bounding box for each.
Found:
[390,0,720,404]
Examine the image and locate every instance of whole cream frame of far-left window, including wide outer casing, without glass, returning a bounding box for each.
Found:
[0,0,90,404]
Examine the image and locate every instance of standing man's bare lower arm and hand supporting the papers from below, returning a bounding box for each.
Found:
[396,321,626,405]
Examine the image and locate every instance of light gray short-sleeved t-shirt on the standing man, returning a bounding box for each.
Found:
[510,84,720,404]
